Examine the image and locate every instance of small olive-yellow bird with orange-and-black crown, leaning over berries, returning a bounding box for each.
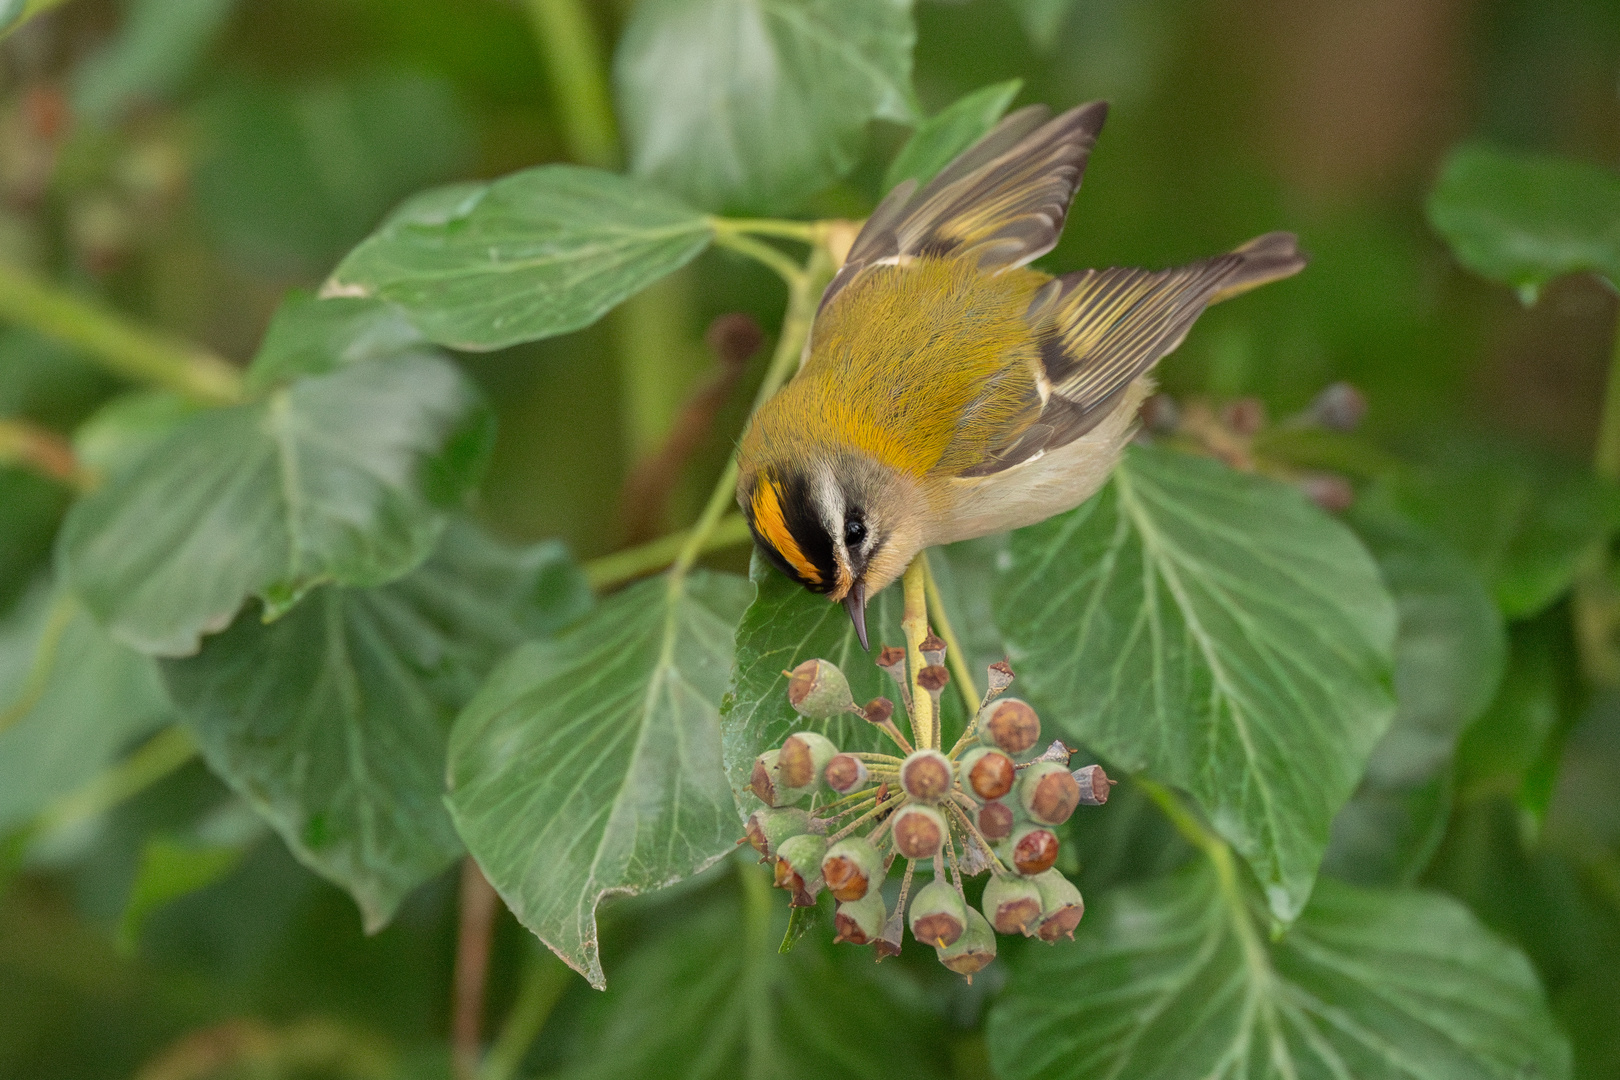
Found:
[737,102,1306,648]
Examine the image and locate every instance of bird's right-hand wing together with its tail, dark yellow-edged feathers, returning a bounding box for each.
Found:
[962,233,1306,476]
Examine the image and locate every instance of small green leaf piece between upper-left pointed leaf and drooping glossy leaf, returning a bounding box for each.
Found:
[246,288,428,393]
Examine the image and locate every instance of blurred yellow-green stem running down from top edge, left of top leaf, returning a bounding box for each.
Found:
[527,0,619,168]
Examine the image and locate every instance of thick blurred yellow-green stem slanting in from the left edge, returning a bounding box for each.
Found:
[0,264,243,405]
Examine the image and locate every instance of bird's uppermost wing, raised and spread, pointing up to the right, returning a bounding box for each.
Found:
[821,102,1108,308]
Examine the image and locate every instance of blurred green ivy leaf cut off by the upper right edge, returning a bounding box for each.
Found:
[1427,146,1620,303]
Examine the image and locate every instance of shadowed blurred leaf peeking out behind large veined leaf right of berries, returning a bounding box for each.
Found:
[1322,495,1507,884]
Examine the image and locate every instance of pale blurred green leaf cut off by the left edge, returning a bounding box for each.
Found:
[0,588,175,832]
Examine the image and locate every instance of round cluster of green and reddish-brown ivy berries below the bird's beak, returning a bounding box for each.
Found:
[747,633,1113,981]
